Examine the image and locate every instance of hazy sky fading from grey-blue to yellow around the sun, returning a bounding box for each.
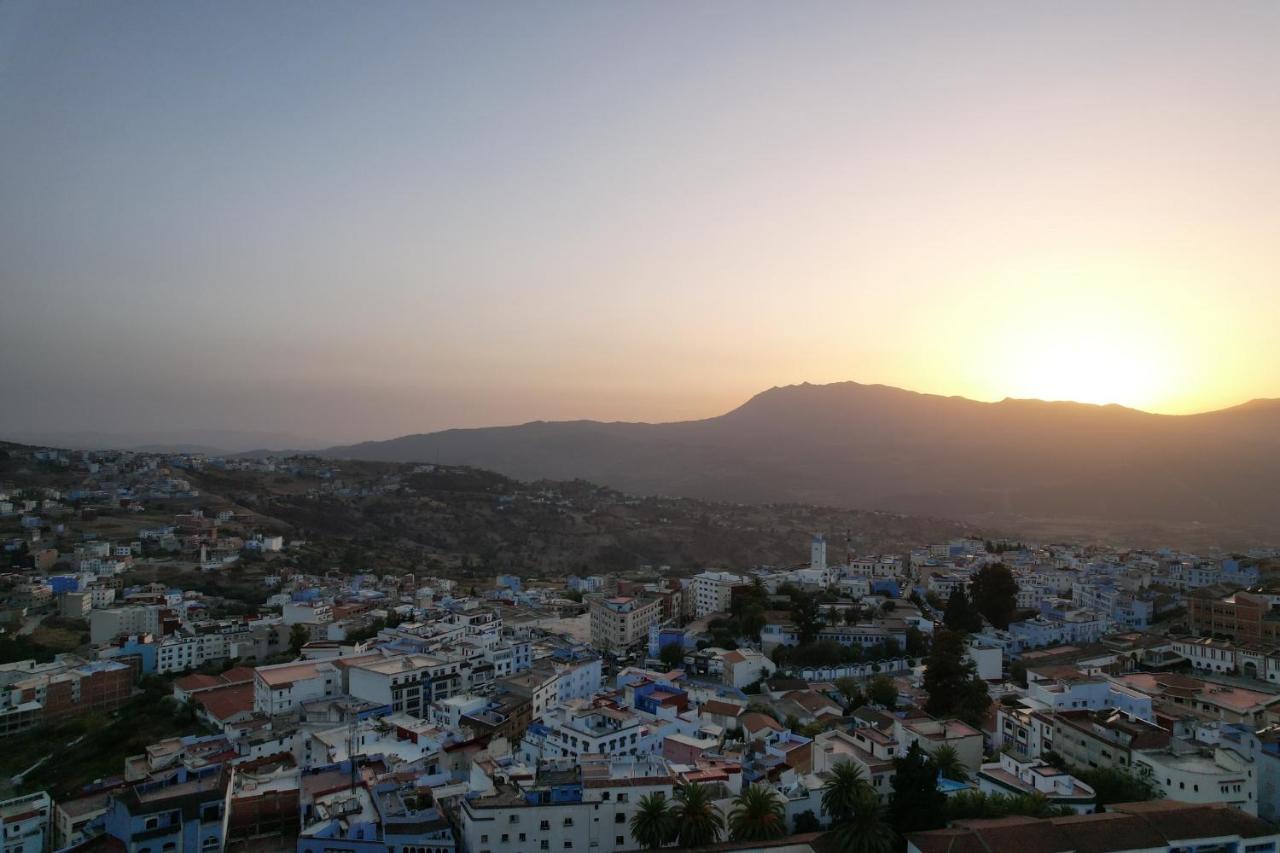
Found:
[0,0,1280,443]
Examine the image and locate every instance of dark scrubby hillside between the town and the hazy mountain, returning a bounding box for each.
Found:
[185,461,977,580]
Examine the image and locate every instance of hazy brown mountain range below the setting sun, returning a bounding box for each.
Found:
[323,382,1280,535]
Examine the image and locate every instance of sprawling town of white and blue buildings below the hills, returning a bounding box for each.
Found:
[0,444,1280,853]
